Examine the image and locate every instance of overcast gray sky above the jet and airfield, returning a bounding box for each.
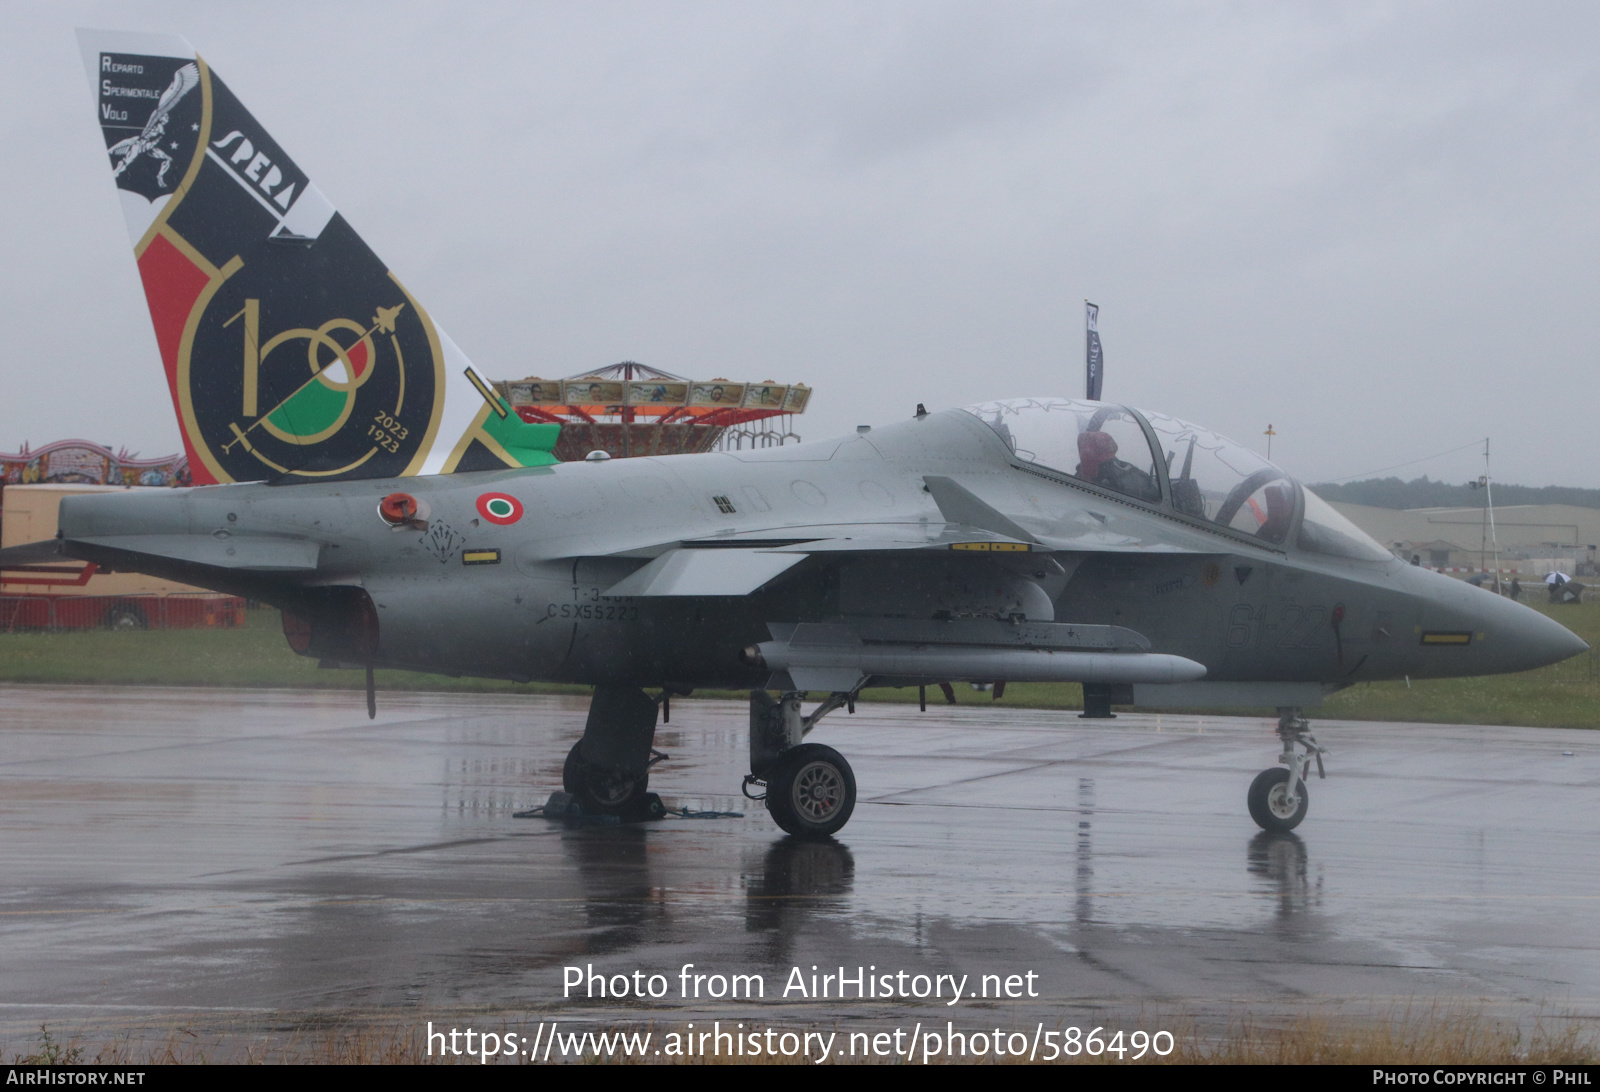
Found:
[0,0,1600,487]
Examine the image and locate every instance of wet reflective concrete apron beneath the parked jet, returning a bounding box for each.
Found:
[0,687,1600,1044]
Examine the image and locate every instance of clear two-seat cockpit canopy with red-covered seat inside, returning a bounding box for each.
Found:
[966,399,1392,560]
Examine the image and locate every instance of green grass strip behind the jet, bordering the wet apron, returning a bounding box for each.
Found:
[0,602,1600,729]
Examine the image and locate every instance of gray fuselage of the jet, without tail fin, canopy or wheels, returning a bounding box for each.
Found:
[61,412,1586,689]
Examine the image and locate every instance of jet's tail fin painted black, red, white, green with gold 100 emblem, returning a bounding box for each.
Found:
[78,30,560,484]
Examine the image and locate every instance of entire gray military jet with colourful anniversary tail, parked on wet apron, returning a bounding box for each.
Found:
[0,32,1587,837]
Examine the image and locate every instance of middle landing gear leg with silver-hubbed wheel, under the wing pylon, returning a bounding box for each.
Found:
[744,690,856,837]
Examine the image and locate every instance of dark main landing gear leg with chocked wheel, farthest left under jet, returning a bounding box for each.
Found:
[562,687,664,818]
